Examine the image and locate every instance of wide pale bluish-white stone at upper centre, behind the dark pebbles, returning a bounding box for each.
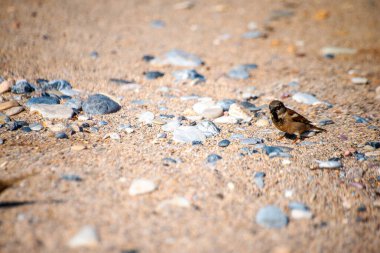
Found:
[150,49,203,68]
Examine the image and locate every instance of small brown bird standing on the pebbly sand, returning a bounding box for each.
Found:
[269,100,326,143]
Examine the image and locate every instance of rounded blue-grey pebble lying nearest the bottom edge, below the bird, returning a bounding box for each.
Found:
[256,205,289,228]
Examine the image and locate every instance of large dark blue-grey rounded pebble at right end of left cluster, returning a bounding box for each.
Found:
[83,94,121,115]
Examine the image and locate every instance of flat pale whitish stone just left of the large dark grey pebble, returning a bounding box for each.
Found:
[30,104,74,119]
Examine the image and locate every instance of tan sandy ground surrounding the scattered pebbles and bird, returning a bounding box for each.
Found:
[0,0,380,252]
